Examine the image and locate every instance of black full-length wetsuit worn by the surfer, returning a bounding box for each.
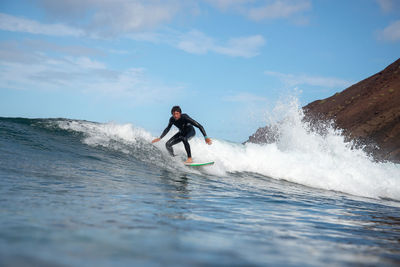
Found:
[160,113,207,158]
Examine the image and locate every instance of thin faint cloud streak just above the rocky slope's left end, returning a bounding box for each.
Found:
[264,71,352,88]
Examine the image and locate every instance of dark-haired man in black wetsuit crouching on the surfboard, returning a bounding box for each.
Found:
[152,106,212,163]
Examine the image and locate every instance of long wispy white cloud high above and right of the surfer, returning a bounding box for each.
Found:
[130,30,265,58]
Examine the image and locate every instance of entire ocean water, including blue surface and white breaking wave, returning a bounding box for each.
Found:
[0,104,400,266]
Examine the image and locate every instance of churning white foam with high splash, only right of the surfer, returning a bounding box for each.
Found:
[188,98,400,200]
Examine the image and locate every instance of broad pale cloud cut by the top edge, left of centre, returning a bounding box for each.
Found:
[39,0,183,37]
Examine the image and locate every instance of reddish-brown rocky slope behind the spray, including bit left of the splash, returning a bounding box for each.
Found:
[248,59,400,162]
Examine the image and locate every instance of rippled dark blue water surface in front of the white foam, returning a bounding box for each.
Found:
[0,119,400,266]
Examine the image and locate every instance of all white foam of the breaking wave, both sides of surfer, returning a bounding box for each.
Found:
[55,100,400,200]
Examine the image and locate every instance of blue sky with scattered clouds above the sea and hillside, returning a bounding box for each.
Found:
[0,0,400,141]
